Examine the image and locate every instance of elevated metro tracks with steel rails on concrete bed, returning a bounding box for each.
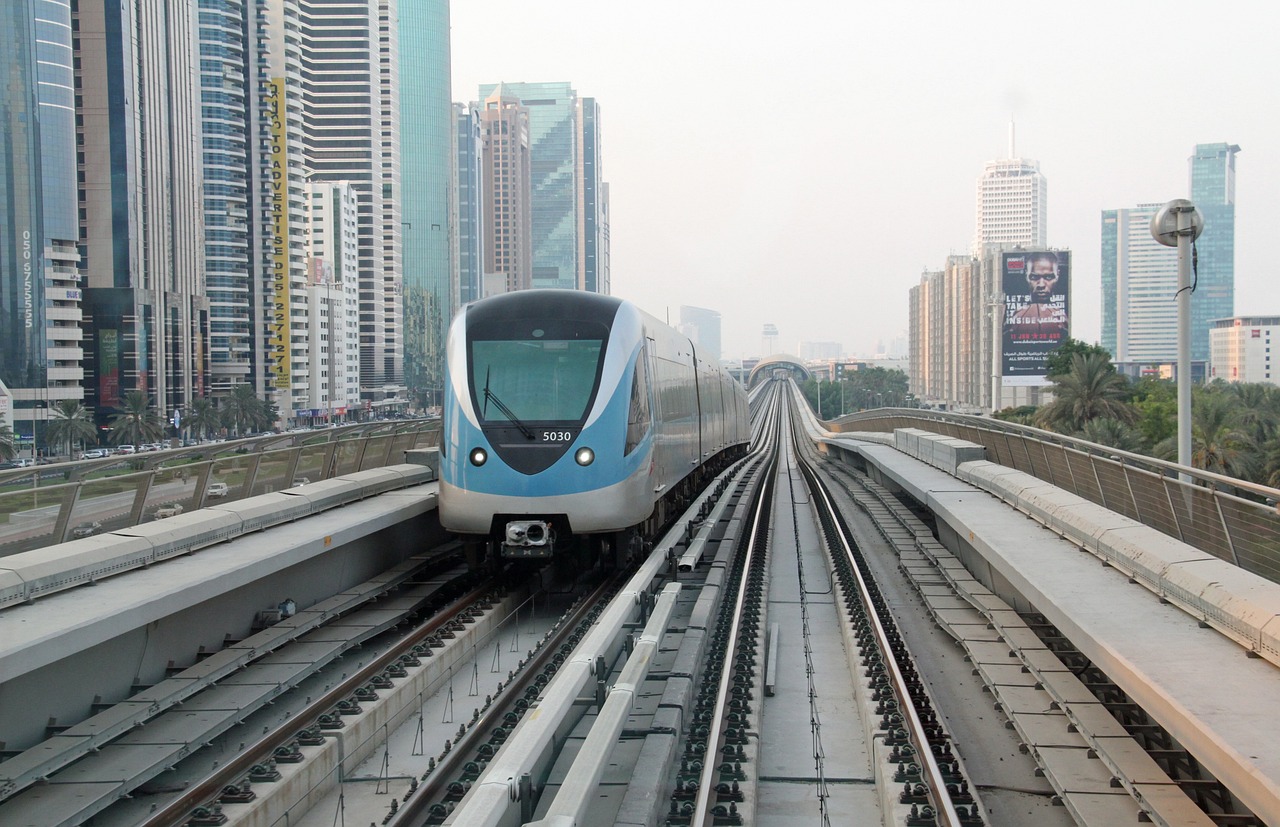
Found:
[0,383,1239,827]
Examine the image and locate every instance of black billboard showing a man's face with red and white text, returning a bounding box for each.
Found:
[1000,251,1071,387]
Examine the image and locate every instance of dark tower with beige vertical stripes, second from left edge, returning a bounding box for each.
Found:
[72,0,209,421]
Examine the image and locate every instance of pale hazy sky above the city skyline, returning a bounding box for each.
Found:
[452,0,1280,358]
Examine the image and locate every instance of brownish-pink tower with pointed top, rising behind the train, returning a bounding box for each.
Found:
[480,83,534,296]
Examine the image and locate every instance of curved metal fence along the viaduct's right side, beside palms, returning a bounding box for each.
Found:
[831,408,1280,582]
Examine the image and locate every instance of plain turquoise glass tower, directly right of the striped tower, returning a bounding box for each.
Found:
[404,0,460,405]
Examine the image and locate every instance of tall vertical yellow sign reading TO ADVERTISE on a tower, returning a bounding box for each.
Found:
[266,78,292,390]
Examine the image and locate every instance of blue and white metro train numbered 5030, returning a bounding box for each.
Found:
[439,289,750,558]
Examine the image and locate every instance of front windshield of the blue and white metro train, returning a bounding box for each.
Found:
[471,330,604,422]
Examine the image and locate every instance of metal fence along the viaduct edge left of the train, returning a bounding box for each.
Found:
[0,420,440,557]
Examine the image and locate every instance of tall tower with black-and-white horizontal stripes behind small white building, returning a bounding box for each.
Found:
[300,0,403,402]
